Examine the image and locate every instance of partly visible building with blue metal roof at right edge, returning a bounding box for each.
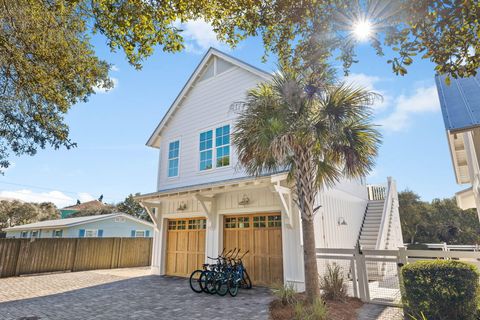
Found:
[435,74,480,219]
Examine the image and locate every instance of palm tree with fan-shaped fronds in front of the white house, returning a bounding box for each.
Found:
[232,68,381,301]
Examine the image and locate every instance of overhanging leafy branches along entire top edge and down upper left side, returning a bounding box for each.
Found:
[0,0,480,169]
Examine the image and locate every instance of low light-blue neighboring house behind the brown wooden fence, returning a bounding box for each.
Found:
[3,212,153,238]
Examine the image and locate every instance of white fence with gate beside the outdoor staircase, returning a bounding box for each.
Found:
[317,248,480,306]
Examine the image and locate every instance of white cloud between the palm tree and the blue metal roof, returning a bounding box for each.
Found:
[380,85,440,131]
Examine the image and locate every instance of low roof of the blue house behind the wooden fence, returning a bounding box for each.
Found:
[3,212,153,231]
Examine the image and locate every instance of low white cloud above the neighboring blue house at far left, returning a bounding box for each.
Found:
[0,189,94,208]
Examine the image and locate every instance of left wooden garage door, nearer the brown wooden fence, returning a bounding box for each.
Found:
[166,218,207,277]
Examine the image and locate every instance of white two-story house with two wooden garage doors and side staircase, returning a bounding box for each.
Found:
[137,48,403,289]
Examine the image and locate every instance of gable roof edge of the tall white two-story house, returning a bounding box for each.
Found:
[146,47,271,148]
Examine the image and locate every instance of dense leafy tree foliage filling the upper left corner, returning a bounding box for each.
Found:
[0,0,112,169]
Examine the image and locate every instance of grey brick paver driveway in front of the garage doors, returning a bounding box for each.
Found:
[0,268,272,320]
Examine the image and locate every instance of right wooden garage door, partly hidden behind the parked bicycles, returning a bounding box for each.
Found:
[223,213,283,286]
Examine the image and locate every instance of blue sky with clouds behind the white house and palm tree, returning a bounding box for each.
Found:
[0,22,462,206]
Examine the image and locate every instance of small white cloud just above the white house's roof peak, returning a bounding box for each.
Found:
[174,19,226,54]
